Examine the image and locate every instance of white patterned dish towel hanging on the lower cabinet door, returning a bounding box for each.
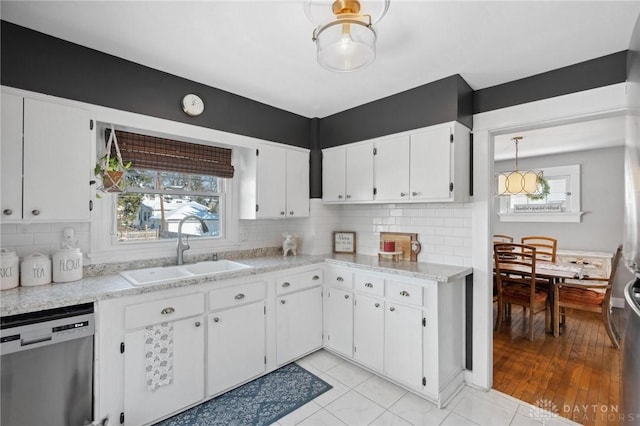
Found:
[144,322,173,391]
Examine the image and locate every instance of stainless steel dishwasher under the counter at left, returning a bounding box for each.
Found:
[0,303,95,426]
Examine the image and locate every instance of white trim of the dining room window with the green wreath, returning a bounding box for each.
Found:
[498,164,584,223]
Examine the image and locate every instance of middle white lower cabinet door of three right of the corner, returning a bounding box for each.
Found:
[353,295,384,371]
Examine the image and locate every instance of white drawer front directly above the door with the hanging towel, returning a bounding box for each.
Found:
[124,294,204,329]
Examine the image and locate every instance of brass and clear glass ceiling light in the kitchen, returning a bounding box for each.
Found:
[305,0,389,72]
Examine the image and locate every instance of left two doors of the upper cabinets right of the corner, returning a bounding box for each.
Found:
[322,143,373,203]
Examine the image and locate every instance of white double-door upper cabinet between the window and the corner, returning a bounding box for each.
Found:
[238,144,309,219]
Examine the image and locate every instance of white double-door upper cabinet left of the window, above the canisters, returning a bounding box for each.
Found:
[2,93,92,222]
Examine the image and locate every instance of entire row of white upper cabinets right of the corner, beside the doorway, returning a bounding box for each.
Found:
[322,122,471,203]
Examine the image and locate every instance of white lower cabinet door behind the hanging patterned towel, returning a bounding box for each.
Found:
[124,317,204,425]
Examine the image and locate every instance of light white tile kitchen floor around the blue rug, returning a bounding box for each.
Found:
[274,350,577,426]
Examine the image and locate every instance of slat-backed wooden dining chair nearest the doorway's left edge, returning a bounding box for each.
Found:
[493,243,551,341]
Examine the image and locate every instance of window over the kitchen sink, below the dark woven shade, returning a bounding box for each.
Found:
[116,169,225,242]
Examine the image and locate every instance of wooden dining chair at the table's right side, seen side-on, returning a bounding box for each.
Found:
[553,245,622,349]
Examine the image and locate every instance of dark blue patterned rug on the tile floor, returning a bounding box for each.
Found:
[156,363,332,426]
